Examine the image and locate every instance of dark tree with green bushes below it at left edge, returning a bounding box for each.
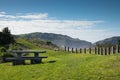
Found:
[0,27,15,62]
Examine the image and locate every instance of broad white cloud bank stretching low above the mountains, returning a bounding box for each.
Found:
[0,12,114,42]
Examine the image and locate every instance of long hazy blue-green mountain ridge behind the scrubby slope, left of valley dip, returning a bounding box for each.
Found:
[15,32,93,48]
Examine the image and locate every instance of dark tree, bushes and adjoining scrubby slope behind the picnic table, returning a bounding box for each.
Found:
[0,27,58,63]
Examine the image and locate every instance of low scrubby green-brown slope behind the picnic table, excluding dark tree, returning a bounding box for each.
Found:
[16,38,58,49]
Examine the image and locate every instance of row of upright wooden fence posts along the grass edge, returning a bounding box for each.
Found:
[64,45,120,55]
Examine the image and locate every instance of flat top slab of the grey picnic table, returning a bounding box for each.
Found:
[10,50,46,53]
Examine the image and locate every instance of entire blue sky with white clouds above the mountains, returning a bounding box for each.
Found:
[0,0,120,43]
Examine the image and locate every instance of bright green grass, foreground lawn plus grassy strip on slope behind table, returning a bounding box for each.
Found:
[0,40,120,80]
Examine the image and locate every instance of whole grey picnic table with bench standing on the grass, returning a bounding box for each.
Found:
[6,50,47,65]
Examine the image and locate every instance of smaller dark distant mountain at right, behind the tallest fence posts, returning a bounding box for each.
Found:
[95,36,120,45]
